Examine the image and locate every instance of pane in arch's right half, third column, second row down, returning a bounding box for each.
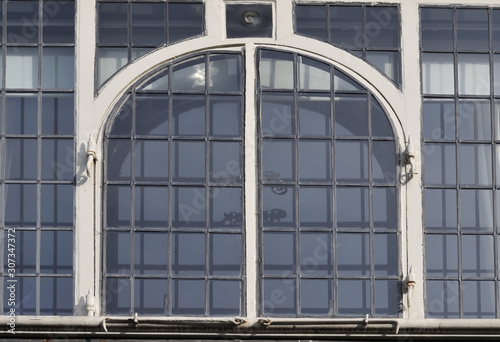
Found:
[333,95,368,137]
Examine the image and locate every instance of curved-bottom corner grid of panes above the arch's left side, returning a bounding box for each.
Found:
[97,0,204,86]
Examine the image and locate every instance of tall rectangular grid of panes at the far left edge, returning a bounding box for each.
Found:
[0,1,75,315]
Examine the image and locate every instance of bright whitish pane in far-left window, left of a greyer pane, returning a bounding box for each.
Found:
[5,46,38,89]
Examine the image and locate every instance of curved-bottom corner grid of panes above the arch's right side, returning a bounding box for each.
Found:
[295,4,401,86]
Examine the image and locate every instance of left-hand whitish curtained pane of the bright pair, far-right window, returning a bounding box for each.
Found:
[422,53,456,94]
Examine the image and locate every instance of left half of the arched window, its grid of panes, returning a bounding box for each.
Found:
[104,53,244,316]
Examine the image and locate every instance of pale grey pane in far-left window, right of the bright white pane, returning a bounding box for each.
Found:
[42,47,75,89]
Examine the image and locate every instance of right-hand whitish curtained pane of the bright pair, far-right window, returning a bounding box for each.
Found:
[458,53,490,95]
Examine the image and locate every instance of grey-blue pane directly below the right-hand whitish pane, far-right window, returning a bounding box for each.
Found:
[458,100,491,140]
